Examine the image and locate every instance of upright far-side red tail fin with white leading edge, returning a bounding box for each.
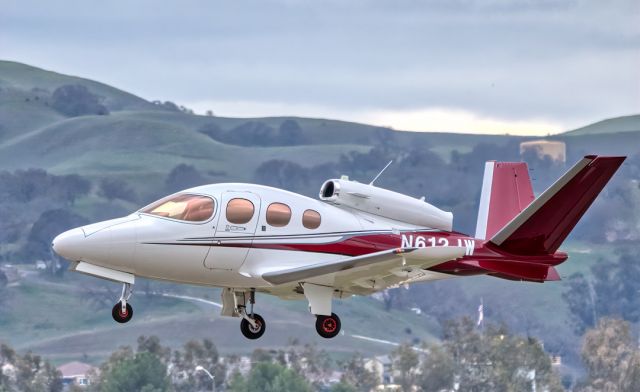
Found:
[476,161,533,239]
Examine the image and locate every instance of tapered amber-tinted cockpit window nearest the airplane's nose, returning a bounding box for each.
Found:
[142,194,214,222]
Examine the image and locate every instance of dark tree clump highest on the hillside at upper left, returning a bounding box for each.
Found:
[51,84,109,117]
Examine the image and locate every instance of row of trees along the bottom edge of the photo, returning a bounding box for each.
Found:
[0,318,640,392]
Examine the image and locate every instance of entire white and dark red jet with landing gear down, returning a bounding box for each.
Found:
[52,156,625,339]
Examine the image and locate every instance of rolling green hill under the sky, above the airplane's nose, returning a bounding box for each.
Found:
[0,61,512,191]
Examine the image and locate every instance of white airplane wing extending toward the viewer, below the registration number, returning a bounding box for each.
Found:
[262,246,466,294]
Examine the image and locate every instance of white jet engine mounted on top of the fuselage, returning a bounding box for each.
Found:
[320,178,453,231]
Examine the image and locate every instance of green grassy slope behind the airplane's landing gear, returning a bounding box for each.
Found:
[0,267,437,362]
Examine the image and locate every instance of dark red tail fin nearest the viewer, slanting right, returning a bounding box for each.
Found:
[491,155,626,255]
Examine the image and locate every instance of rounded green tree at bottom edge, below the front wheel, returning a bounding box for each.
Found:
[100,352,171,392]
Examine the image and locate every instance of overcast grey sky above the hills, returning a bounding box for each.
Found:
[0,0,640,134]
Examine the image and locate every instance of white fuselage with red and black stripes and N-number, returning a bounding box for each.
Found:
[57,184,566,291]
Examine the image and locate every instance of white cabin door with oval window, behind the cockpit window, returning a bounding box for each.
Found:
[204,191,260,270]
